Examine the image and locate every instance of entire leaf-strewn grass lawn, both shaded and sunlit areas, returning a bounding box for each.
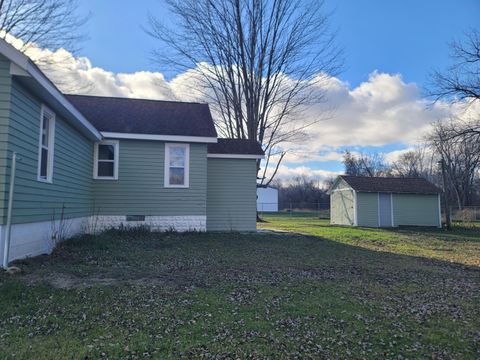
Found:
[0,216,480,359]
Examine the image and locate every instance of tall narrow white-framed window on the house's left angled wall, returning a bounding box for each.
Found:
[37,105,55,182]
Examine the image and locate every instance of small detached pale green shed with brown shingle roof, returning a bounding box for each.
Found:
[329,176,442,227]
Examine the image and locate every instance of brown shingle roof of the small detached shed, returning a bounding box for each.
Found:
[340,175,442,194]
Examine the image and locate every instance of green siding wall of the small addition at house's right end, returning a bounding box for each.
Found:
[207,158,257,231]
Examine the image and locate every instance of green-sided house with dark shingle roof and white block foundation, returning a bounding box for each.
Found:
[0,40,263,260]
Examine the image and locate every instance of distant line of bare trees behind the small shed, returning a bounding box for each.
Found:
[274,131,480,210]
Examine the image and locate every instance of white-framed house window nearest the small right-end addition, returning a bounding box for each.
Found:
[165,144,190,187]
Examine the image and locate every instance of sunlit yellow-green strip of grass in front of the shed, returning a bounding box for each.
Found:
[258,212,480,267]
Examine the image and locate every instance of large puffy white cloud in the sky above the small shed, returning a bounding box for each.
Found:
[305,72,449,152]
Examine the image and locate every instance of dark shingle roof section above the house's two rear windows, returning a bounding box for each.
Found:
[65,95,217,137]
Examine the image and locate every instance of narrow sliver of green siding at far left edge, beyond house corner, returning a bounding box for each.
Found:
[0,55,12,223]
